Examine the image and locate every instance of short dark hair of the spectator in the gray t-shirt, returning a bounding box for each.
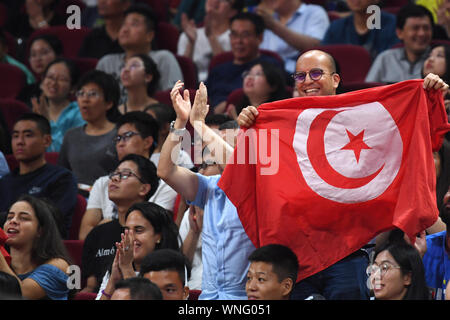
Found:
[76,70,120,122]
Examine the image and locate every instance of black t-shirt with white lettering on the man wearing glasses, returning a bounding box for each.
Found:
[81,219,125,291]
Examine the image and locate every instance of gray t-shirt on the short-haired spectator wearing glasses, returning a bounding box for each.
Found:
[58,126,117,186]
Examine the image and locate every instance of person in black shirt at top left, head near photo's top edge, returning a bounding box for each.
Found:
[78,0,131,59]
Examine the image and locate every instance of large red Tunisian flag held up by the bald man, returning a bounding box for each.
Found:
[219,80,450,281]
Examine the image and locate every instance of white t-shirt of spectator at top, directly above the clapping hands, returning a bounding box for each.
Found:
[177,27,231,81]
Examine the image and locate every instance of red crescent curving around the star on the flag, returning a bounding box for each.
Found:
[306,110,384,189]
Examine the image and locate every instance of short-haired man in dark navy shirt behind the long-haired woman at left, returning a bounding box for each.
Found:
[0,113,77,236]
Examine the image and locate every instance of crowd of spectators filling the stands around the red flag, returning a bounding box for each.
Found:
[0,0,450,300]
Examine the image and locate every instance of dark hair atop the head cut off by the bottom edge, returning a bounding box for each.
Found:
[115,277,163,300]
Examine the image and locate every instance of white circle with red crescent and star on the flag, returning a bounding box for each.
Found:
[293,102,403,203]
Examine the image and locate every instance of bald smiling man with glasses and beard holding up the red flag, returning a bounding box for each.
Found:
[237,50,448,300]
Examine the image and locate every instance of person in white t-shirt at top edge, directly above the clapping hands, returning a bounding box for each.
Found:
[177,0,244,81]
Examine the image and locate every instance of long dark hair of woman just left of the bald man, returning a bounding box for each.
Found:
[236,61,290,114]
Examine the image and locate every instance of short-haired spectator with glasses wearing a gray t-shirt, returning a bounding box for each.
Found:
[58,70,120,188]
